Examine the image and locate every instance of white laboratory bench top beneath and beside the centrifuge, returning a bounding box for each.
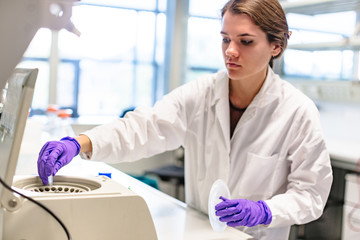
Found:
[16,154,253,240]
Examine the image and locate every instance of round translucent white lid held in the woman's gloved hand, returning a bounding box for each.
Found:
[208,179,230,232]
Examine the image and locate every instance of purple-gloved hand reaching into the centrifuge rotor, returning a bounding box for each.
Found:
[37,137,80,185]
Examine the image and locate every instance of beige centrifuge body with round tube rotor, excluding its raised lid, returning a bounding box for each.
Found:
[3,176,157,240]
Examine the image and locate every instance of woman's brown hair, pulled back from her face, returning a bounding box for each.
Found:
[221,0,290,67]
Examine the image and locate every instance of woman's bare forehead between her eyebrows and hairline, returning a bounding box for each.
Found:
[221,12,265,35]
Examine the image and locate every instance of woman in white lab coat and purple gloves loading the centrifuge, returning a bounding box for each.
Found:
[38,0,332,240]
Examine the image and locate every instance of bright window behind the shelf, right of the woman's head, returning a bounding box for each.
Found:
[284,11,357,80]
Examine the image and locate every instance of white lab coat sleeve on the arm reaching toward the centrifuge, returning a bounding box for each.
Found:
[81,80,195,163]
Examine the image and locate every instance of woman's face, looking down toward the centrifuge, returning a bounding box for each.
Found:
[221,12,281,80]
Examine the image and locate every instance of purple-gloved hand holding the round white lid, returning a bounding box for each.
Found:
[215,197,272,227]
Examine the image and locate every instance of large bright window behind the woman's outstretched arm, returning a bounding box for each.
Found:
[21,0,166,116]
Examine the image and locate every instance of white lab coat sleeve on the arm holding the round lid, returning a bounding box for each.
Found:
[266,104,333,227]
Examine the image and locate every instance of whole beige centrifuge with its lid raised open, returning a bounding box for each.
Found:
[0,69,157,240]
